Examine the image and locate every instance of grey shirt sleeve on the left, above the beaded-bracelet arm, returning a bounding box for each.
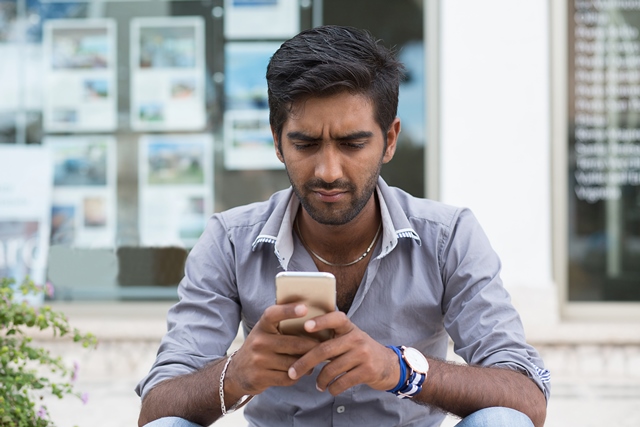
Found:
[136,215,240,397]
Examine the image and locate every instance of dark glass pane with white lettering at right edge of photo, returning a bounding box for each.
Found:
[568,1,640,301]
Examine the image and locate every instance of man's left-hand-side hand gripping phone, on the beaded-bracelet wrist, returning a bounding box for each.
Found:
[225,303,324,396]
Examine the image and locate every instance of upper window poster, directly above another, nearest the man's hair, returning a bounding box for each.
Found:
[130,16,206,131]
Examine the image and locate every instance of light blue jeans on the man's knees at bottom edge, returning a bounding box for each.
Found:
[145,408,533,427]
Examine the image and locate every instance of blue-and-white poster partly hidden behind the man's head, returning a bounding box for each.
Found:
[224,42,284,170]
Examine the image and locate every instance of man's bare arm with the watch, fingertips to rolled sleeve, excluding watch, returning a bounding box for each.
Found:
[289,312,546,427]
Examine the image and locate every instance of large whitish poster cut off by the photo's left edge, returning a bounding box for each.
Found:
[0,145,51,292]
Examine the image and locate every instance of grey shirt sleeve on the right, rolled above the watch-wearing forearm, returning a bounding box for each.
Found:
[439,209,550,400]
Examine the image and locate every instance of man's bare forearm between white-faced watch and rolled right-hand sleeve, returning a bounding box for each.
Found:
[414,359,546,427]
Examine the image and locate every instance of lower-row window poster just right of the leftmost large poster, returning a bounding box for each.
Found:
[44,135,116,248]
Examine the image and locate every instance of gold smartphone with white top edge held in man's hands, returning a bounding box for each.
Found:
[276,271,336,341]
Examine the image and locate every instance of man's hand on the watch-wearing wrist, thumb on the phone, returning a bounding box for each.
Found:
[289,311,400,396]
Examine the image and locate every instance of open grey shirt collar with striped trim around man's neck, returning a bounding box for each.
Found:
[251,177,422,271]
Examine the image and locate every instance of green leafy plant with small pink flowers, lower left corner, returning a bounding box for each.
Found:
[0,278,97,427]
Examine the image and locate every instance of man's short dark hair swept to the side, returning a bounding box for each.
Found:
[267,25,404,142]
